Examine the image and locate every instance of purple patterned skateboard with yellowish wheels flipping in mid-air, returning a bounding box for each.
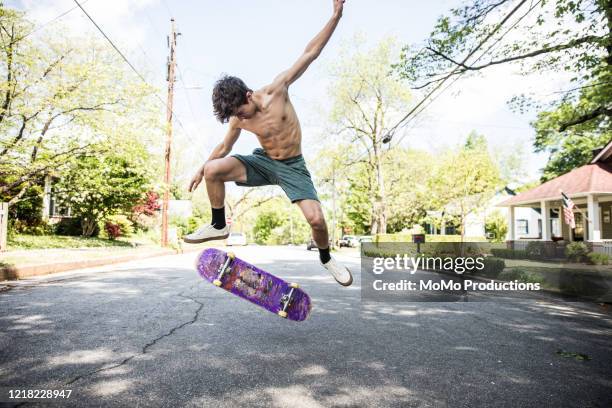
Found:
[196,248,312,321]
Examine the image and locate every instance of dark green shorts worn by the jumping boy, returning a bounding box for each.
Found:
[232,148,319,203]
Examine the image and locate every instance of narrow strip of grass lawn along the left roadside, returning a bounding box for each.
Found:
[8,235,146,251]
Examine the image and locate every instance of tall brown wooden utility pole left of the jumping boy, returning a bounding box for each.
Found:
[161,18,178,247]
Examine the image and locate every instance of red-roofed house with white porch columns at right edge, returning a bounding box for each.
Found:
[498,141,612,254]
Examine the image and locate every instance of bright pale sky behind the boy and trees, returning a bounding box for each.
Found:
[10,0,567,186]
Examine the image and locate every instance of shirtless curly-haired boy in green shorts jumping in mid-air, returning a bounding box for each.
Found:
[184,0,353,286]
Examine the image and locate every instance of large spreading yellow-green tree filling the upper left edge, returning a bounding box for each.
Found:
[0,6,162,205]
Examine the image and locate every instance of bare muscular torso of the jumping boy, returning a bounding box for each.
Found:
[235,85,302,160]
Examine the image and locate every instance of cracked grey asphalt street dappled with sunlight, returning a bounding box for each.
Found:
[0,246,612,408]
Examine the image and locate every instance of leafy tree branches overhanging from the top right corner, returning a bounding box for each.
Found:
[396,0,612,180]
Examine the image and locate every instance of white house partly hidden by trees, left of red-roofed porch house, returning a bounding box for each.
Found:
[425,187,540,238]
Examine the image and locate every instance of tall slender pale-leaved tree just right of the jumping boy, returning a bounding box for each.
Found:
[330,38,411,233]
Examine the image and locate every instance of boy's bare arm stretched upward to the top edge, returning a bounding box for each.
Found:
[272,0,344,87]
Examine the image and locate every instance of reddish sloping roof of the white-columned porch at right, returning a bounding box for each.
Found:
[498,163,612,207]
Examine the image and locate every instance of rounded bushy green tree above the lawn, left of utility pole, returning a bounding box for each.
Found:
[54,144,151,237]
